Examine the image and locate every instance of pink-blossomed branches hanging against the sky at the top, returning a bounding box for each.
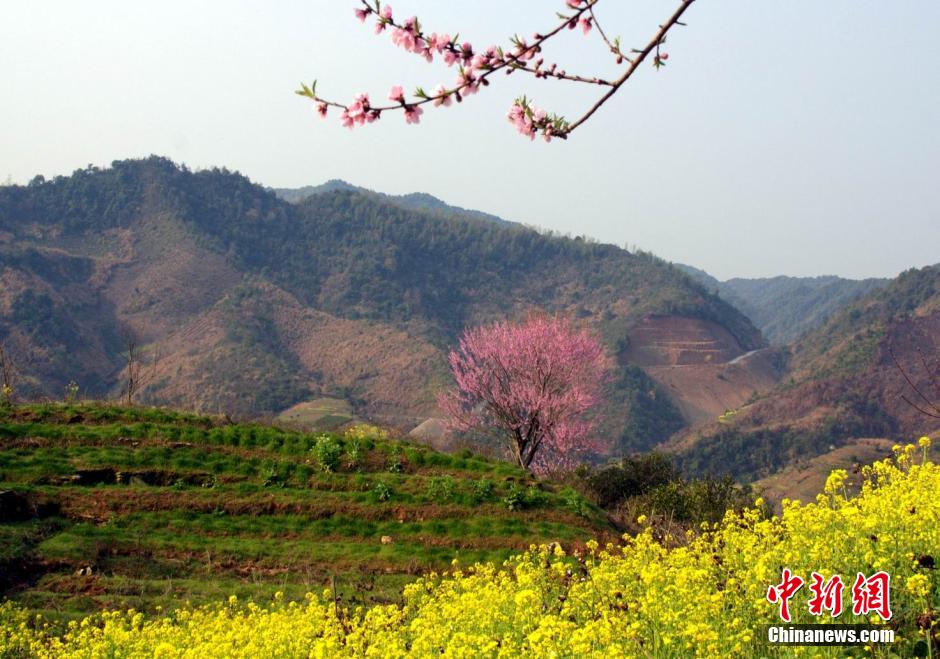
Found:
[297,0,695,141]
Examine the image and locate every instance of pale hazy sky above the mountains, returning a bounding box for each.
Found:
[0,0,940,278]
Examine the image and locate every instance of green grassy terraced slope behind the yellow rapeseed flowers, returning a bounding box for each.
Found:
[0,404,614,621]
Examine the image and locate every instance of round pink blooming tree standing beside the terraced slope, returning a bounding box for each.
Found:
[439,315,611,471]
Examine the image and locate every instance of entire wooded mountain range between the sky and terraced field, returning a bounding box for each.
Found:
[0,157,940,488]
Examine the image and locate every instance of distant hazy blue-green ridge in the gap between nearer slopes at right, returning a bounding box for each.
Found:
[674,263,891,346]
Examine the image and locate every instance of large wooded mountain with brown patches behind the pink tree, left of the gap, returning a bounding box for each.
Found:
[0,157,763,452]
